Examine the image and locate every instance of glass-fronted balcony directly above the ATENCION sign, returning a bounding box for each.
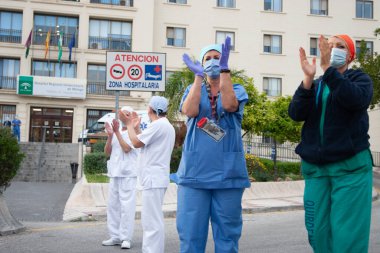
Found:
[88,35,132,51]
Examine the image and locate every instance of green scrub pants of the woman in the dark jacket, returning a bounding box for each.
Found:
[304,169,372,253]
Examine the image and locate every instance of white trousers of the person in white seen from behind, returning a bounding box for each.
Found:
[141,188,166,253]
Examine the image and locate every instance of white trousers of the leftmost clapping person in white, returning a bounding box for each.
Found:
[107,177,136,241]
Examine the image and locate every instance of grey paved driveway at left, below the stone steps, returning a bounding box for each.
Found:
[4,182,74,221]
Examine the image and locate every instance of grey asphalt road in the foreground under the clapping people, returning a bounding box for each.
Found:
[0,200,380,253]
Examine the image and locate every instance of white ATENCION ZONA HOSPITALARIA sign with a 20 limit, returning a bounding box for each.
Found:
[106,51,166,91]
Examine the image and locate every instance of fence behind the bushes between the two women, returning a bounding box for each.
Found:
[243,137,380,167]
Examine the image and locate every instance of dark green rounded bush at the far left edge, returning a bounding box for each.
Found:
[0,127,25,194]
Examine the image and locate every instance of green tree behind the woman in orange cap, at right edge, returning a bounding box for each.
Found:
[353,39,380,109]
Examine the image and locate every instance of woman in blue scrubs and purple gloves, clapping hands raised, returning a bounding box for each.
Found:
[171,37,250,253]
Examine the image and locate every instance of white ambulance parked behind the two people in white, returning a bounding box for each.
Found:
[78,110,149,143]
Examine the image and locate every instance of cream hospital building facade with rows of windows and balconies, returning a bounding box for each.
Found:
[0,0,380,148]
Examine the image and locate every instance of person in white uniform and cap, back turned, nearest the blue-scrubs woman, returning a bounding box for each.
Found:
[119,96,175,253]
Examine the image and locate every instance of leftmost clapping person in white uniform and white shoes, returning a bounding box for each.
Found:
[102,106,140,249]
